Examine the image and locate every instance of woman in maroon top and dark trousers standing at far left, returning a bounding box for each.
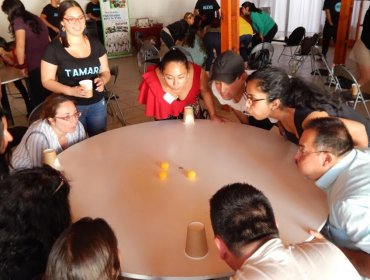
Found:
[1,0,49,108]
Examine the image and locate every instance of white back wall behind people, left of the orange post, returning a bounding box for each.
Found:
[0,0,196,40]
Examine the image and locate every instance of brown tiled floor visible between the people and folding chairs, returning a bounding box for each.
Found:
[4,44,363,129]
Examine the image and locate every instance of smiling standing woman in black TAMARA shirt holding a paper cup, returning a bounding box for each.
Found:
[41,0,110,136]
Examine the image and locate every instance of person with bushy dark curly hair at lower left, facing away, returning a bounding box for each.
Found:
[0,165,71,279]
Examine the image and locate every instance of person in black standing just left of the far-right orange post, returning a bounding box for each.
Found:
[322,0,341,57]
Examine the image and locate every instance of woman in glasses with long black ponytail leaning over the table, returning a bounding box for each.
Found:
[246,67,370,147]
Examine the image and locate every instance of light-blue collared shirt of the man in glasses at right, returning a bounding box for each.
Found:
[316,149,370,254]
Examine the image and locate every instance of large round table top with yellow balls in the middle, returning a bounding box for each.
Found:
[59,120,328,279]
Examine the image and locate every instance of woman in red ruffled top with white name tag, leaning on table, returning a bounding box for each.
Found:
[138,49,221,120]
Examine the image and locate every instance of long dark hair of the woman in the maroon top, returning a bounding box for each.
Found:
[1,0,42,36]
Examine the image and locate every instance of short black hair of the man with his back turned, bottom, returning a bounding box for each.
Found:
[210,183,279,256]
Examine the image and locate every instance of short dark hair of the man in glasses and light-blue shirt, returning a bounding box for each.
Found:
[304,117,354,156]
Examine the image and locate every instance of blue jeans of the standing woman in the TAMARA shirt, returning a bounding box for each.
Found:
[77,98,107,137]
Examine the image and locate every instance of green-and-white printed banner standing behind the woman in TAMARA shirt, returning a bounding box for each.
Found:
[100,0,131,58]
